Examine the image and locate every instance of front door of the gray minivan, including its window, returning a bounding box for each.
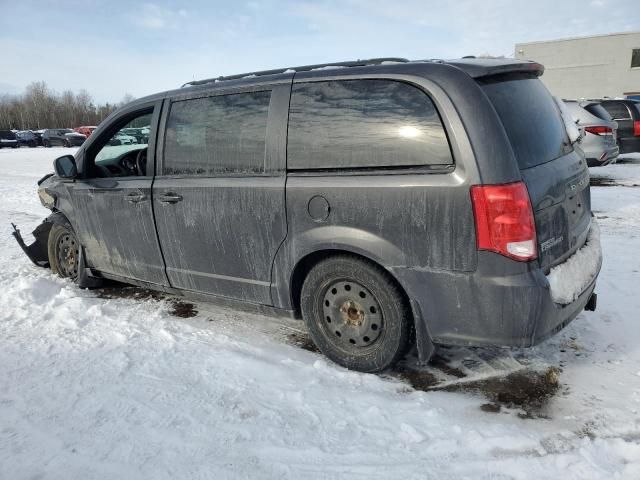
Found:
[71,102,167,285]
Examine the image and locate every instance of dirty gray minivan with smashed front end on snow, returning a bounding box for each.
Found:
[14,59,601,372]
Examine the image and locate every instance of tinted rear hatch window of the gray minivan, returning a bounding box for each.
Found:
[480,75,572,169]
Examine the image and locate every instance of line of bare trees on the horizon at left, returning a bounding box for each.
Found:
[0,82,133,130]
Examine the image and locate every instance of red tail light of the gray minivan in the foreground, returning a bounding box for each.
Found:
[471,182,537,261]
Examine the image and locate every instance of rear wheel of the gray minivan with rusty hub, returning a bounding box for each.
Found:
[300,254,413,373]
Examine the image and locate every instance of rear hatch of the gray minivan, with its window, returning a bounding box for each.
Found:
[477,73,591,272]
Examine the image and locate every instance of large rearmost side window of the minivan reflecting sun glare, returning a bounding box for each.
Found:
[287,80,453,170]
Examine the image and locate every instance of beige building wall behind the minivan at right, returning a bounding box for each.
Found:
[515,32,640,99]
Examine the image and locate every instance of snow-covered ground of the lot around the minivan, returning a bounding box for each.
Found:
[0,148,640,480]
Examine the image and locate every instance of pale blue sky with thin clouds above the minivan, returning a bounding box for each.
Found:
[0,0,640,102]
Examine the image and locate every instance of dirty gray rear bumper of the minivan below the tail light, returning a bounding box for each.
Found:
[393,222,602,347]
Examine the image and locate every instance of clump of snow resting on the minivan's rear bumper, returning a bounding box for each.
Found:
[547,220,602,305]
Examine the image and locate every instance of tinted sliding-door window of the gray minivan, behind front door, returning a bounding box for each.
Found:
[162,91,271,176]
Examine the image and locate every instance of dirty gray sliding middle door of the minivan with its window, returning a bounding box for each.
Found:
[153,83,289,304]
